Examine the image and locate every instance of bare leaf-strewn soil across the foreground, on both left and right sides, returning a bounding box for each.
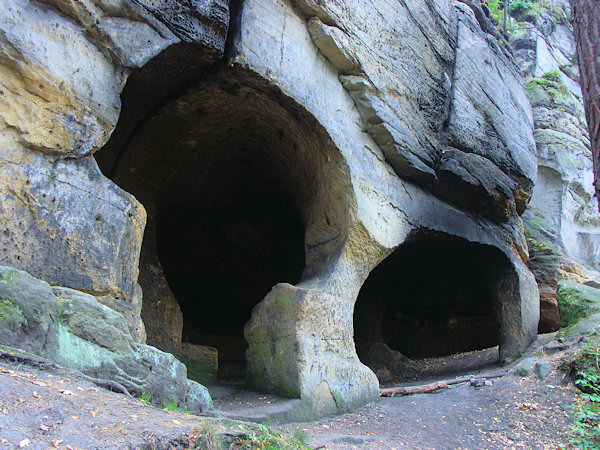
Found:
[0,336,577,449]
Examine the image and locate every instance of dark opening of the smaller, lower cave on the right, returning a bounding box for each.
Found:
[354,231,510,383]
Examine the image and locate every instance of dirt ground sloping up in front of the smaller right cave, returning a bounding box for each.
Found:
[284,373,576,449]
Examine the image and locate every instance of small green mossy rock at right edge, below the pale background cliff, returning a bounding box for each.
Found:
[556,280,600,327]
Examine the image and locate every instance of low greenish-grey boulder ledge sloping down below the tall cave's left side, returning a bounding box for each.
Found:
[0,267,212,412]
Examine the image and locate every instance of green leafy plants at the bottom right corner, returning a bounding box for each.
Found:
[565,335,600,449]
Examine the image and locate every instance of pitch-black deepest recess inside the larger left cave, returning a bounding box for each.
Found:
[157,147,304,378]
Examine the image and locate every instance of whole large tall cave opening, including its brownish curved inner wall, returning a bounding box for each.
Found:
[97,62,348,383]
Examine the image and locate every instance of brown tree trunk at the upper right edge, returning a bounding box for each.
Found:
[570,0,600,209]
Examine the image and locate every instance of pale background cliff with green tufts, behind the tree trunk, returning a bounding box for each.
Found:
[510,2,600,332]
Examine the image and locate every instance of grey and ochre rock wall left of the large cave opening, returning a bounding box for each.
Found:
[0,0,229,320]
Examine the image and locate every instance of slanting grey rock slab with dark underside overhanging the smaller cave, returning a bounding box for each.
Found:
[297,0,536,221]
